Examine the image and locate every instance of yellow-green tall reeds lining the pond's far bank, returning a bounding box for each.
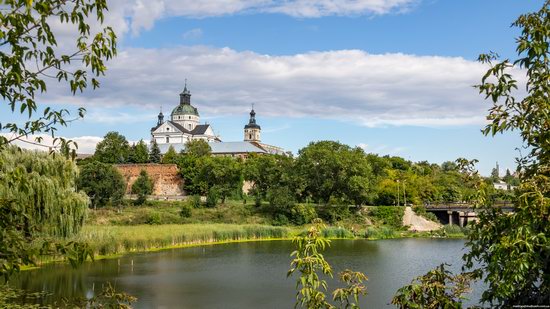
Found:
[78,224,290,255]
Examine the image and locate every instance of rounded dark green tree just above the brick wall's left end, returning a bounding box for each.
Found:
[94,131,130,164]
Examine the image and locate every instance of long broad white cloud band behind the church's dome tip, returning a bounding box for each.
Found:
[36,46,528,126]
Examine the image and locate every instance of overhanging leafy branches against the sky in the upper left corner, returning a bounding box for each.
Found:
[0,0,116,147]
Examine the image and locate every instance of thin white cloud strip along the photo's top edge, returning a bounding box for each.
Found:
[78,0,420,37]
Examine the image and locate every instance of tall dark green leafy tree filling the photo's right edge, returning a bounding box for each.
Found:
[465,1,550,306]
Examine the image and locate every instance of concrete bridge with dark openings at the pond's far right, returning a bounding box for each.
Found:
[425,201,514,227]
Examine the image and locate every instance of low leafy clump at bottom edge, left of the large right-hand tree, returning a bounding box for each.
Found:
[392,264,471,309]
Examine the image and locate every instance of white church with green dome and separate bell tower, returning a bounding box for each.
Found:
[151,83,285,158]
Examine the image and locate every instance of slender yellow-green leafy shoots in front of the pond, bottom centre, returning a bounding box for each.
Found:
[287,219,367,308]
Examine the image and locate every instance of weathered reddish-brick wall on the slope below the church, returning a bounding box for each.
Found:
[115,163,185,196]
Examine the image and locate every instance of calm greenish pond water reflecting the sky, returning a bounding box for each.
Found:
[14,239,484,308]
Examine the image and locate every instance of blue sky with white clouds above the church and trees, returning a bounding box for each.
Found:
[0,0,543,175]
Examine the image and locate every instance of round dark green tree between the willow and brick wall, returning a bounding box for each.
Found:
[77,161,126,209]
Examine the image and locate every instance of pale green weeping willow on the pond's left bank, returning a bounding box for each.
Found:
[0,147,89,280]
